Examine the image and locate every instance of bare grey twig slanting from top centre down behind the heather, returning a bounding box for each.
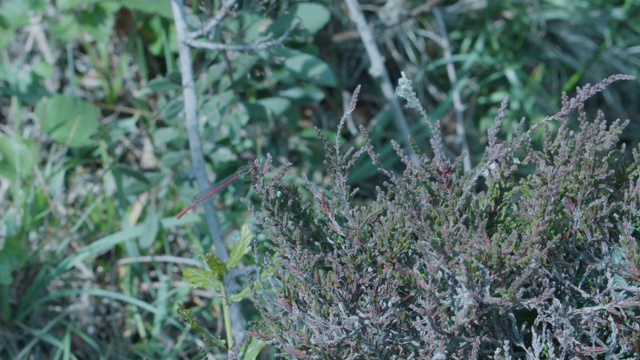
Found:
[345,0,418,163]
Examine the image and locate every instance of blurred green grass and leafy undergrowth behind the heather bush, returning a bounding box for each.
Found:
[0,0,640,359]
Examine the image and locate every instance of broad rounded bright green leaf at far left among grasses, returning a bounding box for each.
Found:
[36,95,100,147]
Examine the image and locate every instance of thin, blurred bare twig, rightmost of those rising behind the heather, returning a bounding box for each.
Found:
[432,7,471,172]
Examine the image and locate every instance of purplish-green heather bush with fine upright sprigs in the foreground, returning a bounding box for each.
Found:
[246,75,640,359]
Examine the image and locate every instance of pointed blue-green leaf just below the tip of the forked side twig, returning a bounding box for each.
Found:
[261,47,337,87]
